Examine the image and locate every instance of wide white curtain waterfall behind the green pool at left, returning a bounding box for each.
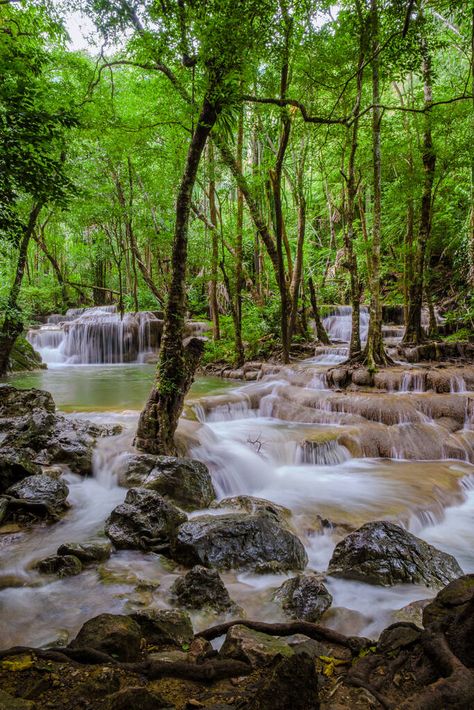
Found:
[28,306,163,365]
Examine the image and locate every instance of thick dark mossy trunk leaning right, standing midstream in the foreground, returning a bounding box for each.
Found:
[135,98,221,454]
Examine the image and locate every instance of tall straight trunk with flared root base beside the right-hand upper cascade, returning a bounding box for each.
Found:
[361,0,390,371]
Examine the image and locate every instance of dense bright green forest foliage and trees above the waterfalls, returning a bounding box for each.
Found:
[0,0,474,378]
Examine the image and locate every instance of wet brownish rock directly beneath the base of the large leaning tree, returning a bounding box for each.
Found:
[143,456,216,510]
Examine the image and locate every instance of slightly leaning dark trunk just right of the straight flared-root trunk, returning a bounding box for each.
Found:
[403,33,436,344]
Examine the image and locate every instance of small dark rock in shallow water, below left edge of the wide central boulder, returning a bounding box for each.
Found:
[171,565,236,612]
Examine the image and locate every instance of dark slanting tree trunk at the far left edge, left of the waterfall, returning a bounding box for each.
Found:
[0,202,43,377]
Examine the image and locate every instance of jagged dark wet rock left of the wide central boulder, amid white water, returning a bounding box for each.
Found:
[105,488,186,552]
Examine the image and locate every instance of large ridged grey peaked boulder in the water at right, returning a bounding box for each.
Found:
[328,521,462,587]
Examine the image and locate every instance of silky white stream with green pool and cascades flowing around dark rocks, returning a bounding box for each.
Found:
[0,364,474,647]
